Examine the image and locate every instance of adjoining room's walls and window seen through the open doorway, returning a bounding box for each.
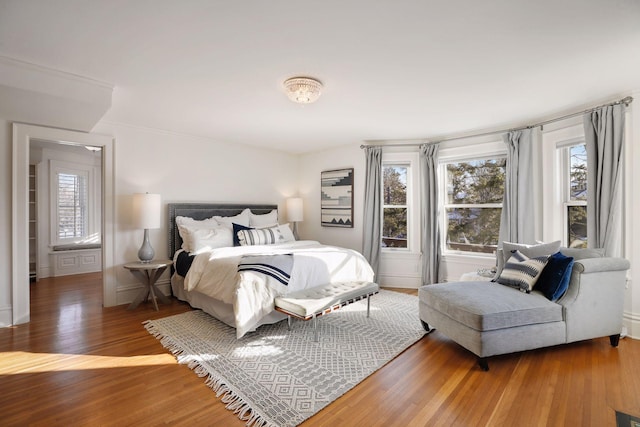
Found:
[29,139,102,283]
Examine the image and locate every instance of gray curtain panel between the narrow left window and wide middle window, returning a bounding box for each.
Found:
[420,144,441,285]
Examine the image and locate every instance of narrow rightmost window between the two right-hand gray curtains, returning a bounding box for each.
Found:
[560,143,587,248]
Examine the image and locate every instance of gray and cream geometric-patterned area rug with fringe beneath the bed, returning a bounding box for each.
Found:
[144,290,425,427]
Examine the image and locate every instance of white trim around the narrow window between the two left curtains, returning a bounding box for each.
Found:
[381,152,420,255]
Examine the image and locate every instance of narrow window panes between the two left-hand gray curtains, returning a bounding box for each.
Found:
[382,164,410,249]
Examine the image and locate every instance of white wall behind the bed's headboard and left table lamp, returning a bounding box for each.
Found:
[94,122,298,304]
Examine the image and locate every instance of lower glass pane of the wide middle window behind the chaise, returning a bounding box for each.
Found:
[447,208,502,253]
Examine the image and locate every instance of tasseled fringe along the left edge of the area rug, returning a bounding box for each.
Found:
[142,320,278,427]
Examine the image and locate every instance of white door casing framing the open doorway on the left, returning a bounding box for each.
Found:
[11,124,116,325]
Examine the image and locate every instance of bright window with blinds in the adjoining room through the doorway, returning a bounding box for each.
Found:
[56,172,88,239]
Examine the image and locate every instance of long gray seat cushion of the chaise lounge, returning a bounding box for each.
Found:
[419,282,563,331]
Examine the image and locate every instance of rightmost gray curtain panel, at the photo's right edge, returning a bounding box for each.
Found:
[583,104,624,256]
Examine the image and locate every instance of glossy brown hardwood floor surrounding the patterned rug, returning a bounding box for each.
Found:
[0,274,640,427]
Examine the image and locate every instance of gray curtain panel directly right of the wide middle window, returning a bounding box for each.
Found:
[498,129,535,246]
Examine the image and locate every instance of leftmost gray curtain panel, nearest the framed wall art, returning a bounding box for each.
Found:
[362,147,382,278]
